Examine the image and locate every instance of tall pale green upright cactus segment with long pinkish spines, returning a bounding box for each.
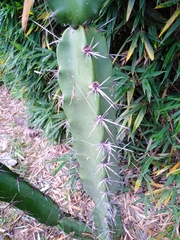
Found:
[57,26,122,240]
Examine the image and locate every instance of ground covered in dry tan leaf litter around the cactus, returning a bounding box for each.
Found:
[0,86,177,240]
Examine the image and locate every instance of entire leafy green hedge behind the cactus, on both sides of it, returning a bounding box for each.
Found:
[0,0,180,237]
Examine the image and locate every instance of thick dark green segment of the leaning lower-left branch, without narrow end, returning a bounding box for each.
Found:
[0,164,61,226]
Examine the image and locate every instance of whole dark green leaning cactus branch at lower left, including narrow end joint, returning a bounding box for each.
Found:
[0,164,93,237]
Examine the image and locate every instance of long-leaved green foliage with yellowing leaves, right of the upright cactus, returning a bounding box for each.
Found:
[101,0,180,222]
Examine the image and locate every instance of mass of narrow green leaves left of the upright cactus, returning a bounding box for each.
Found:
[0,1,66,142]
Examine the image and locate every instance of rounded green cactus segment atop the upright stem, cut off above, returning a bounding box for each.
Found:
[47,0,105,28]
